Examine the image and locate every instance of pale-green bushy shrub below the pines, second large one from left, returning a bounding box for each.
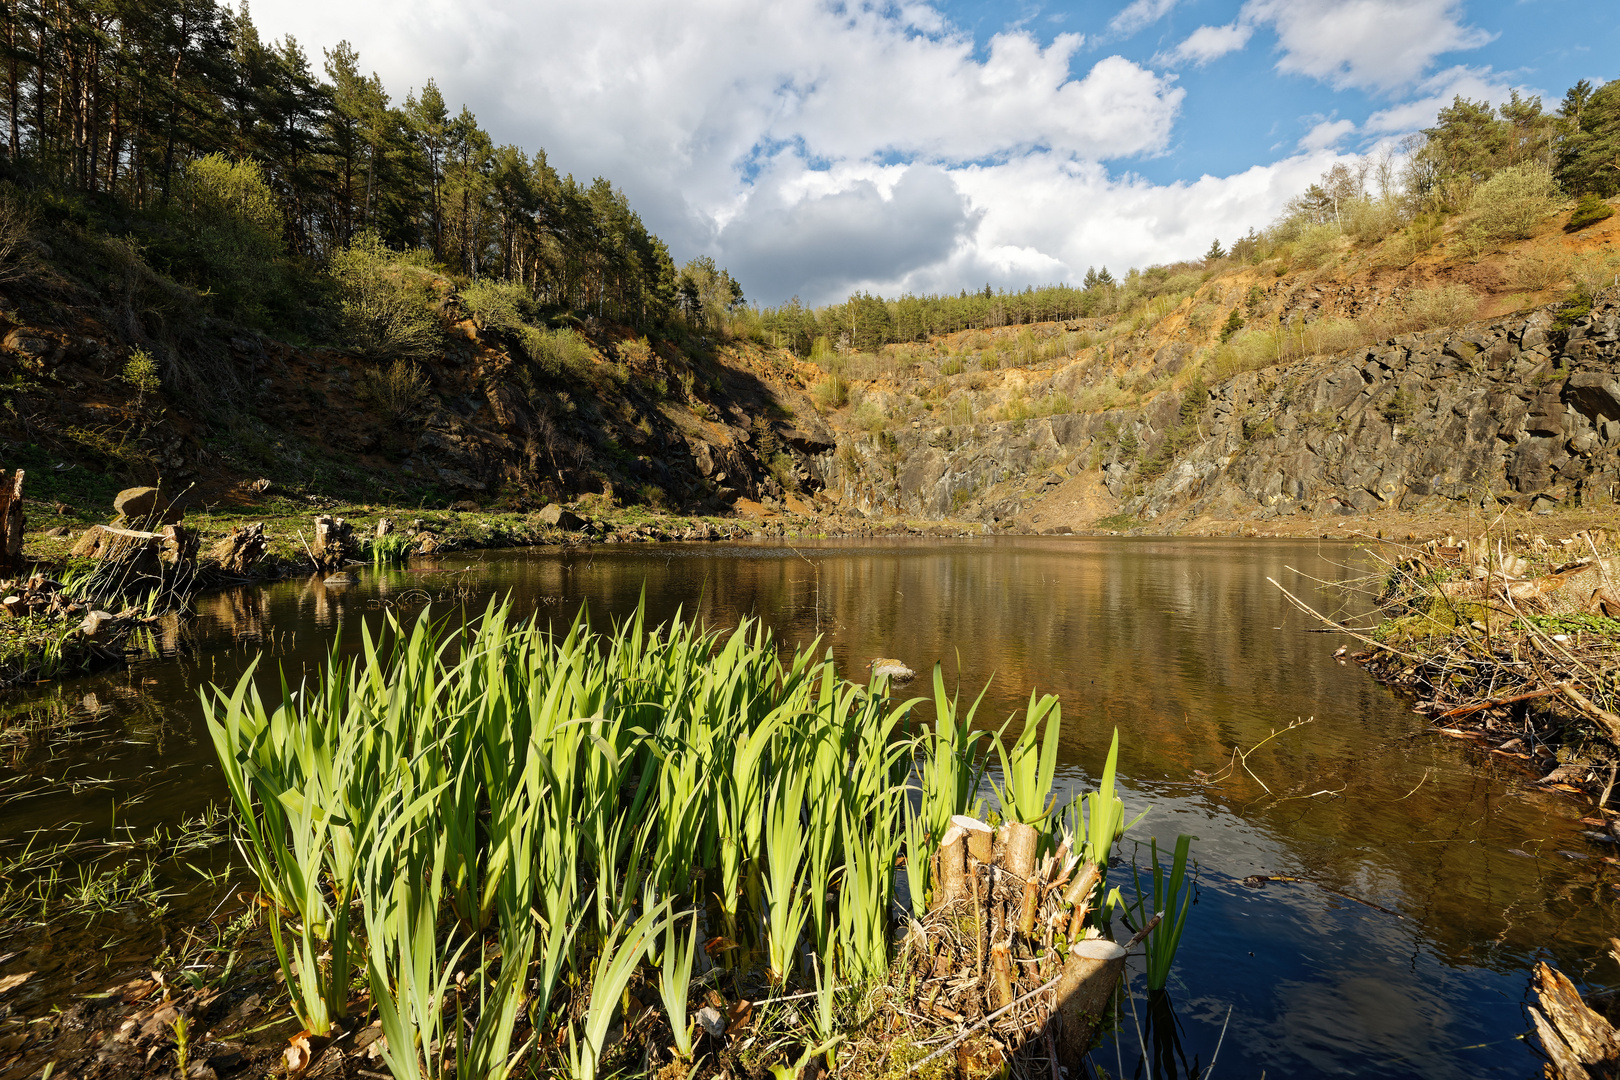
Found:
[332,232,442,361]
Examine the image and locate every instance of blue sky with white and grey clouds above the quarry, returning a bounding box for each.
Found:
[251,0,1620,304]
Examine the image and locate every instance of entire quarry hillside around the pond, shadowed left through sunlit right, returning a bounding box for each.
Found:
[0,183,1620,550]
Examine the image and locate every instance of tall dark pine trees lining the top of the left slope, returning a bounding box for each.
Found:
[0,0,742,333]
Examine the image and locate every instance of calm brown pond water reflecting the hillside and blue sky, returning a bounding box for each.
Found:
[0,538,1620,1077]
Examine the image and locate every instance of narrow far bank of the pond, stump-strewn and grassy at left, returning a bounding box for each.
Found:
[0,495,1607,693]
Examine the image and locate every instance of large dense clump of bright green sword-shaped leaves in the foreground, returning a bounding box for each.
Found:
[204,604,1179,1080]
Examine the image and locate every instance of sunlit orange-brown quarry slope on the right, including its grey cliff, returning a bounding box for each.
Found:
[800,195,1620,534]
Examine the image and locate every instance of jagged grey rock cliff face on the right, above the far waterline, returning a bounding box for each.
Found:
[816,293,1620,531]
